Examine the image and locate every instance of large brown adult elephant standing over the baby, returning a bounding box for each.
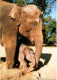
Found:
[0,2,43,68]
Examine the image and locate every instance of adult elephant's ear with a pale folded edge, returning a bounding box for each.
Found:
[9,4,22,25]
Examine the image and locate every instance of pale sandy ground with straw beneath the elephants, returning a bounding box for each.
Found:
[0,45,57,80]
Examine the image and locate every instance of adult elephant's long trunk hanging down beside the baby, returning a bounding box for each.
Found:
[34,19,43,66]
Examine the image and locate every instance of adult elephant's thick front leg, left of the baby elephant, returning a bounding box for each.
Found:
[5,37,16,68]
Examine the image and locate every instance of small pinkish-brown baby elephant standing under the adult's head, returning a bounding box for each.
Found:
[18,44,35,68]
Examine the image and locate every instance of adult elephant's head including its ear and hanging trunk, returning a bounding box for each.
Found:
[9,5,43,66]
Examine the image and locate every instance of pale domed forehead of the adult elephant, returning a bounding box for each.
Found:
[23,5,41,21]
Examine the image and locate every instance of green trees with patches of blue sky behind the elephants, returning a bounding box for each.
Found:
[2,0,56,46]
